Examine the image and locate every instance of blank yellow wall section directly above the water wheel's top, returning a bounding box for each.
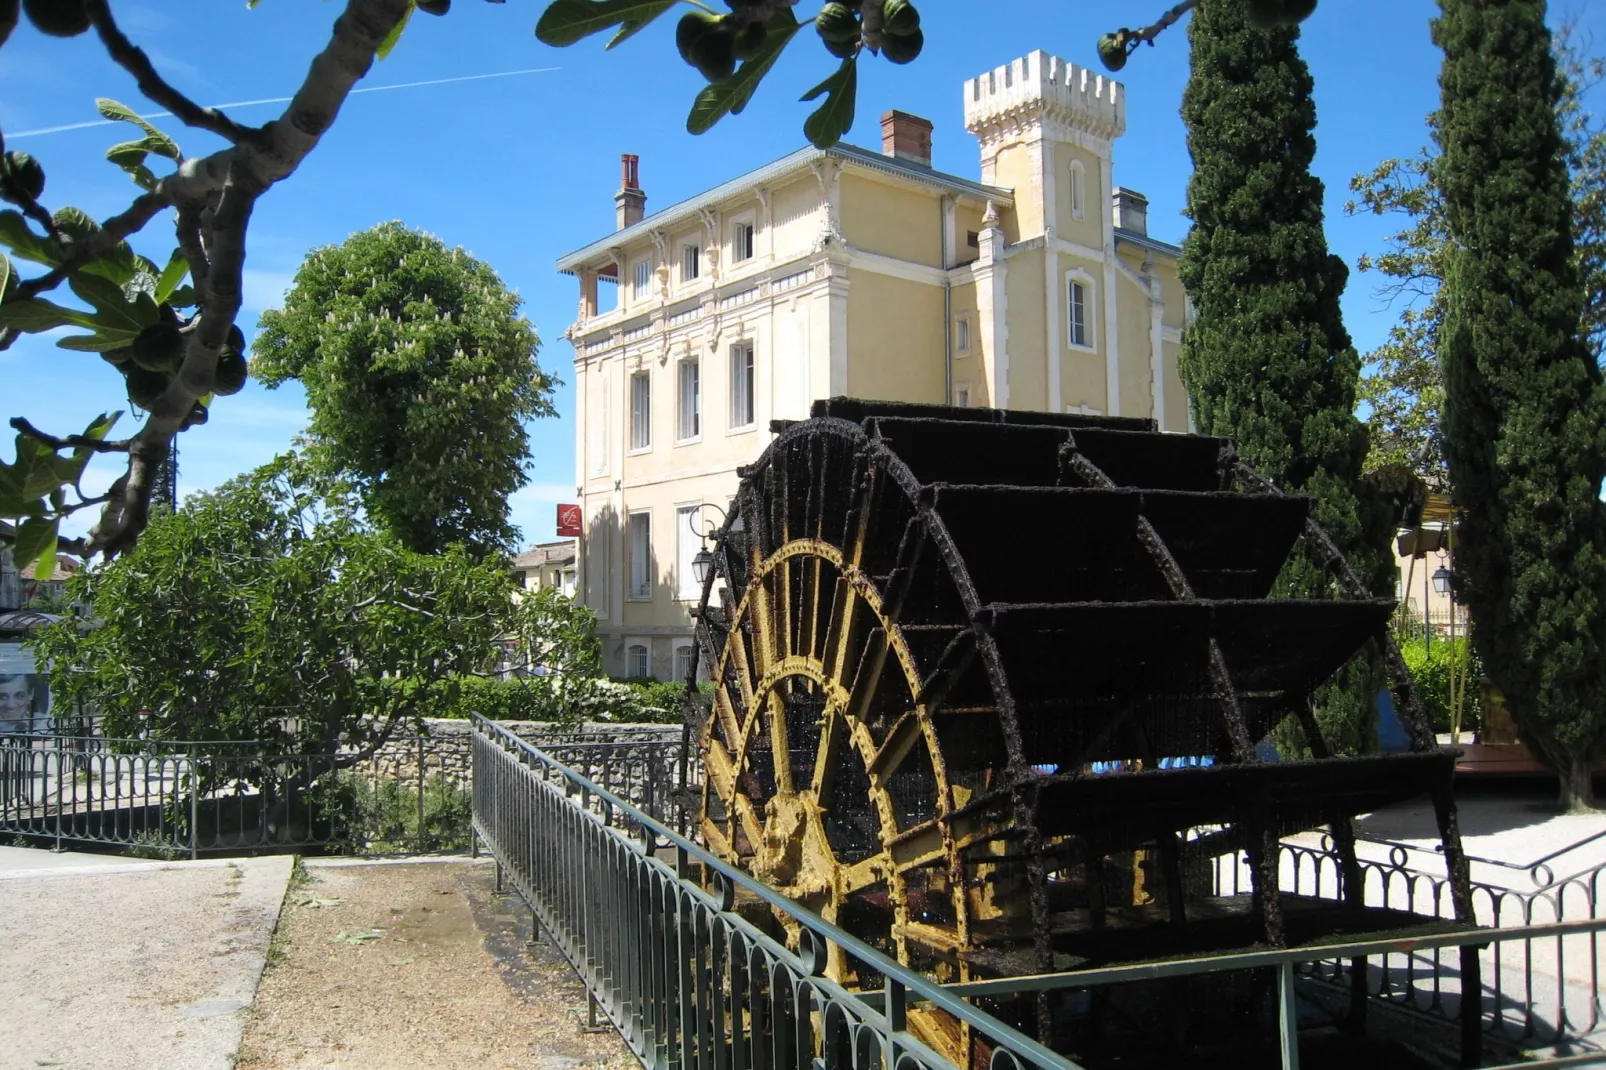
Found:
[848,268,944,403]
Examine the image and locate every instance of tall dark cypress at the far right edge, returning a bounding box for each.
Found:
[1434,0,1606,808]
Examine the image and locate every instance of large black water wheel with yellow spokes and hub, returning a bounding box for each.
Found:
[699,398,1465,1065]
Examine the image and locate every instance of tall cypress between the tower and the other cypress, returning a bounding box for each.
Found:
[1180,0,1394,752]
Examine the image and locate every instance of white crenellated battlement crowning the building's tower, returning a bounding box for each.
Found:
[965,50,1126,143]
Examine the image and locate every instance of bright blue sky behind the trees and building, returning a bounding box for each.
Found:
[0,0,1606,543]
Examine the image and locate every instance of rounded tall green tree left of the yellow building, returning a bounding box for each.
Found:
[252,223,556,556]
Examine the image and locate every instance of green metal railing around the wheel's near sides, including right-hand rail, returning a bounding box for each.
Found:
[474,718,1606,1070]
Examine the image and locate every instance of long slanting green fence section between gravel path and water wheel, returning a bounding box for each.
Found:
[474,718,1076,1070]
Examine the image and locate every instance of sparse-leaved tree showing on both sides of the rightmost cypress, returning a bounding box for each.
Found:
[1344,26,1606,488]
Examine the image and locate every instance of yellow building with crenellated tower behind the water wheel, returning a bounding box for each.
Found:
[557,51,1188,678]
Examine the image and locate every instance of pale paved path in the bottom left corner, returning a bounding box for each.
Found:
[0,852,291,1070]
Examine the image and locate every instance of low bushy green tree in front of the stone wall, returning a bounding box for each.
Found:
[26,458,539,748]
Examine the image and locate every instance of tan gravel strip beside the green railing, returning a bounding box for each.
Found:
[239,863,638,1070]
